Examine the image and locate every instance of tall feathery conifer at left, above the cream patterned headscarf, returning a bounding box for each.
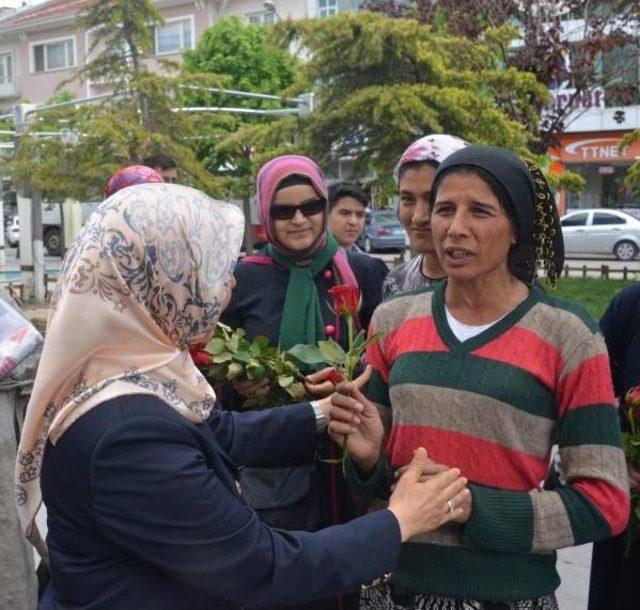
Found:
[12,0,233,201]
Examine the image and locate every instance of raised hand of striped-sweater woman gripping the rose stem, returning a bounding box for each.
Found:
[329,372,384,472]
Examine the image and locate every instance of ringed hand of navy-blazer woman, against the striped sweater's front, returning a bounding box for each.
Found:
[389,447,471,542]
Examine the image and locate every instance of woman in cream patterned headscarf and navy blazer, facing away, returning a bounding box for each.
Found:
[15,184,465,610]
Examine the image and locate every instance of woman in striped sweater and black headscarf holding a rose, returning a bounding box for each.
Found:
[331,146,629,610]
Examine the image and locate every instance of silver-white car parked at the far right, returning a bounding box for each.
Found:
[560,208,640,261]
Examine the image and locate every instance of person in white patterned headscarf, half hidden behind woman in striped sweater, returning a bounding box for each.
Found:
[382,134,468,299]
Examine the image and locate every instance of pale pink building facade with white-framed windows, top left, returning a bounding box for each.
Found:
[0,0,350,110]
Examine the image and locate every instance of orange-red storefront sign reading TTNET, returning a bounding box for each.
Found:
[549,131,640,165]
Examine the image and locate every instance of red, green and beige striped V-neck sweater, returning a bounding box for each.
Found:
[347,282,629,601]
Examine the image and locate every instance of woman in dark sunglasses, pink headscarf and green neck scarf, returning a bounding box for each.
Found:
[222,155,386,609]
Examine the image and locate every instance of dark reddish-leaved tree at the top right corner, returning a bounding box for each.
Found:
[360,0,640,153]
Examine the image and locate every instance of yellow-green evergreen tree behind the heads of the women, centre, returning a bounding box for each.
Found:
[223,12,548,188]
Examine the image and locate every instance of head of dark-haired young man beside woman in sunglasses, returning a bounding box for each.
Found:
[329,182,369,252]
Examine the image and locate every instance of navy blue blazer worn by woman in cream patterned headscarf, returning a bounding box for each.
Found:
[42,394,400,610]
